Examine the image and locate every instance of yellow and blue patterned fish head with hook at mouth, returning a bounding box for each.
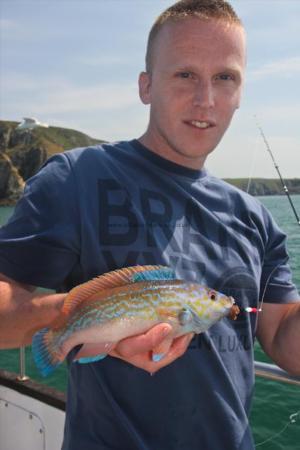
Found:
[178,283,239,333]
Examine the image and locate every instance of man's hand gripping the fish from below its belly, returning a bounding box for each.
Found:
[109,323,193,374]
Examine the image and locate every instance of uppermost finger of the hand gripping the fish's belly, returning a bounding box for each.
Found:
[115,323,172,358]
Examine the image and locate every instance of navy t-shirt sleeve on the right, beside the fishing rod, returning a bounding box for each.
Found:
[260,206,300,303]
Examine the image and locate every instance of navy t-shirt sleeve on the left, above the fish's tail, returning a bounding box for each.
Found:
[0,154,80,289]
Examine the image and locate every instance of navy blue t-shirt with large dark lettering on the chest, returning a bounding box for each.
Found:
[0,140,299,450]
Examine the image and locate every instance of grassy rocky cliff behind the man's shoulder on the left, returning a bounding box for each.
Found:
[0,121,103,206]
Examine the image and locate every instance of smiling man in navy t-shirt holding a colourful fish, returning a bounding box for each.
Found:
[0,0,300,450]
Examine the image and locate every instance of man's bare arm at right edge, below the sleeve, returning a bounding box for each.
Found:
[257,303,300,375]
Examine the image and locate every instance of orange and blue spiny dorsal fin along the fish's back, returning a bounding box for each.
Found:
[62,266,171,314]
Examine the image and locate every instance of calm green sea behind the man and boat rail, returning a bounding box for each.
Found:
[0,195,300,450]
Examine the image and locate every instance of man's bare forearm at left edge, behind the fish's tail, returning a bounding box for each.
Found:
[0,279,66,349]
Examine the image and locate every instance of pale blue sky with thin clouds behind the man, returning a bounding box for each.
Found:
[0,0,300,178]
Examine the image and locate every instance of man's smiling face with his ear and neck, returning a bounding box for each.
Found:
[139,18,246,169]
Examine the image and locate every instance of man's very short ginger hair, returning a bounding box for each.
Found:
[146,0,242,73]
